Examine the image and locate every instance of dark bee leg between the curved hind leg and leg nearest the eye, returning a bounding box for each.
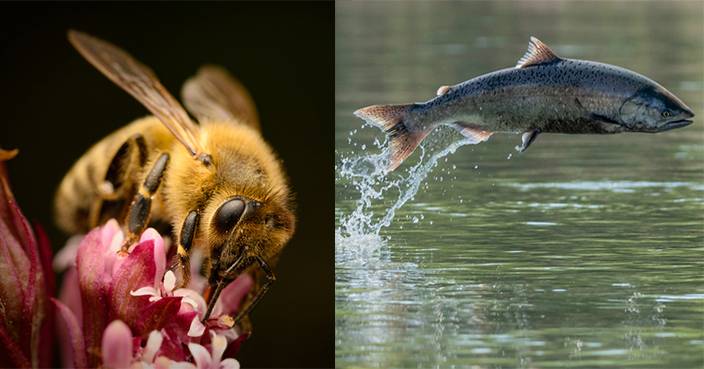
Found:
[120,153,169,253]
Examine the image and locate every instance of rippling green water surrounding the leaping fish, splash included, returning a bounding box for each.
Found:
[335,2,704,368]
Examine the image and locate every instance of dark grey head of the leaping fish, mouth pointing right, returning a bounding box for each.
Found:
[619,85,694,133]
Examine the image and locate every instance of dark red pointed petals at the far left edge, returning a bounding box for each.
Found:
[0,149,54,368]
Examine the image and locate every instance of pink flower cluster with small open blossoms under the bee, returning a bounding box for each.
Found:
[55,220,252,368]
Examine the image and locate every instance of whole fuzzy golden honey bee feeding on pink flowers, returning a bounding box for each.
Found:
[55,30,295,323]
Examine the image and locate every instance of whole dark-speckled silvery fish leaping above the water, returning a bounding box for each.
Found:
[354,37,694,171]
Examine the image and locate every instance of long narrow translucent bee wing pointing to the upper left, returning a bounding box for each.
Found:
[68,30,203,156]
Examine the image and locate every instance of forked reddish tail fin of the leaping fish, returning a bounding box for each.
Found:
[354,104,430,171]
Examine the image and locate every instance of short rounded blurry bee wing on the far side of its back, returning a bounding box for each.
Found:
[181,65,259,130]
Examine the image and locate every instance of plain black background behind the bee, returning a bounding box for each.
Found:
[0,3,334,367]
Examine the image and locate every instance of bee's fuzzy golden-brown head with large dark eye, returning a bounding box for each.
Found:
[208,196,294,283]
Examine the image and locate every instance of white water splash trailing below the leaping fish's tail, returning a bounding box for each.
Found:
[335,129,470,254]
